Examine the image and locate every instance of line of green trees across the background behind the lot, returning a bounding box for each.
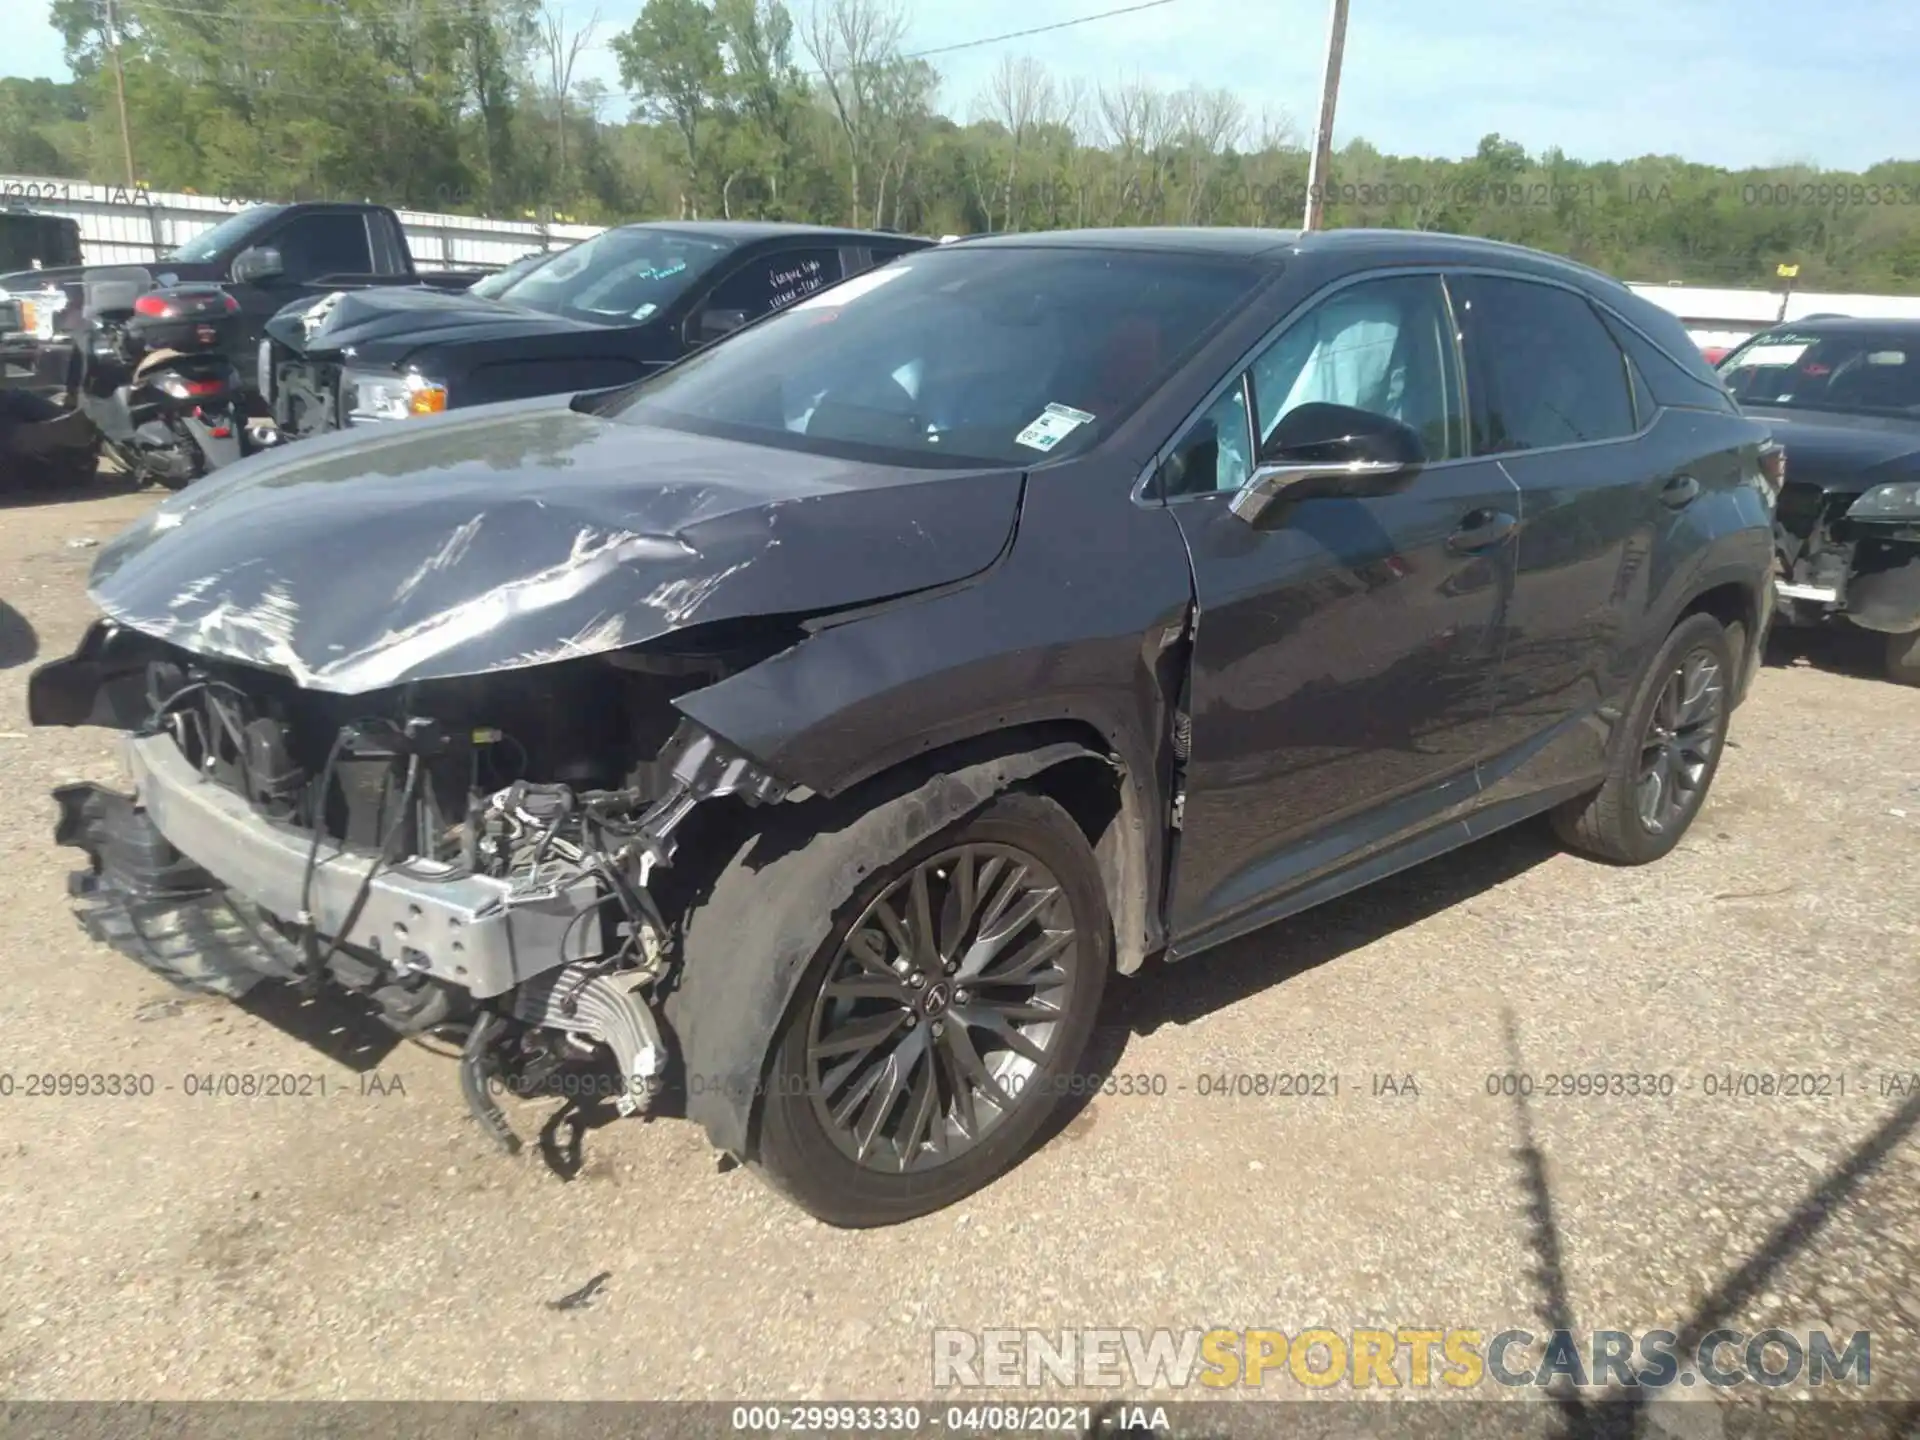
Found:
[0,0,1920,292]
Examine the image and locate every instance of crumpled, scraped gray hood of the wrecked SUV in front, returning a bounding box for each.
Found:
[88,399,1021,695]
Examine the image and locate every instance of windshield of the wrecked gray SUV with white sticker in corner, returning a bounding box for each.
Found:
[612,248,1265,465]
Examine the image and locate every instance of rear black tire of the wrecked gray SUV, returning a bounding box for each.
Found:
[1553,614,1738,866]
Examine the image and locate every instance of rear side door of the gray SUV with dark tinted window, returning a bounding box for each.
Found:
[1448,273,1693,824]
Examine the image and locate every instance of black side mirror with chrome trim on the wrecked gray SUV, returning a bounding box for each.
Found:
[1233,401,1427,524]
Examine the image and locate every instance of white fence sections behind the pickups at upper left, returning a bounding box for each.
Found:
[0,175,601,269]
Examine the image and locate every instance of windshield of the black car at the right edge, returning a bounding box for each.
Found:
[1720,330,1920,415]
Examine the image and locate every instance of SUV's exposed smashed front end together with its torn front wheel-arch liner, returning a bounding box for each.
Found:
[31,549,1116,1154]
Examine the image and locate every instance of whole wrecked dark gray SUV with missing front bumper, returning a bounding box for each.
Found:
[31,230,1774,1225]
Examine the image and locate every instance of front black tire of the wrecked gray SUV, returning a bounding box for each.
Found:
[753,791,1112,1227]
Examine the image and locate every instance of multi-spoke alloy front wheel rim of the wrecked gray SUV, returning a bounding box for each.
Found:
[806,843,1083,1173]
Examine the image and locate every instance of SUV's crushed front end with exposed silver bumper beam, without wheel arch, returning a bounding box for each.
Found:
[29,620,789,1148]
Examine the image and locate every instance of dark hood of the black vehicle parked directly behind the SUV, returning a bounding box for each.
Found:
[267,286,601,363]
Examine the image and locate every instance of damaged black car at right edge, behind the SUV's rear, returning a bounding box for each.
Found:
[1720,317,1920,685]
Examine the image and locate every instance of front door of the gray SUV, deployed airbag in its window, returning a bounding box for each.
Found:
[1162,275,1519,950]
